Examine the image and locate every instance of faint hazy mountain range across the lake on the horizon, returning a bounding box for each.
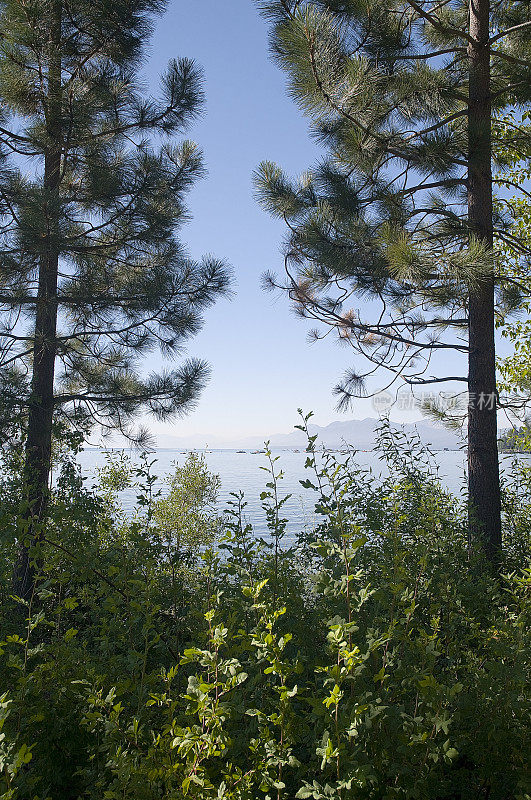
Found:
[158,417,459,450]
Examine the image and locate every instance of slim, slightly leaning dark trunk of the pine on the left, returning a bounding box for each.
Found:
[14,0,62,599]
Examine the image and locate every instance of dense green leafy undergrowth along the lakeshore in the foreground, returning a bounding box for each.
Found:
[0,420,531,800]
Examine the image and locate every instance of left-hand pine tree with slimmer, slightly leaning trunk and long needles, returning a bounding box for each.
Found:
[0,0,233,596]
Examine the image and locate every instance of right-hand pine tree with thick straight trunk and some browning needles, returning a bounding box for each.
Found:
[257,0,531,563]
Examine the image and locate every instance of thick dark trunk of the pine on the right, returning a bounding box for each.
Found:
[468,0,502,565]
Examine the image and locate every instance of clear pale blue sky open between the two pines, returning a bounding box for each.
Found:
[137,0,462,446]
